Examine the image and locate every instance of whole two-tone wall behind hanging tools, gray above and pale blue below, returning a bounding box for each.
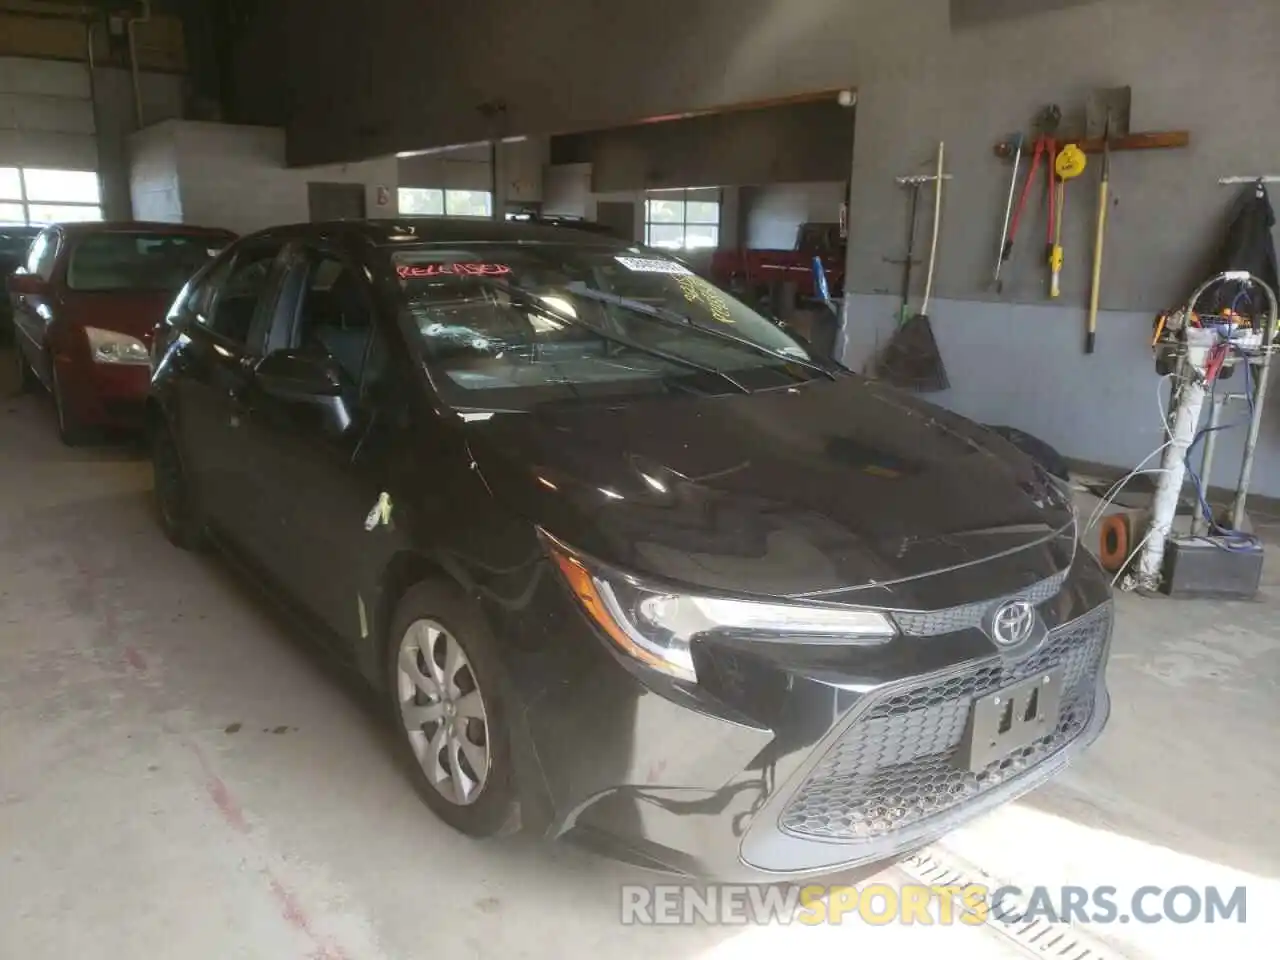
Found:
[844,0,1280,495]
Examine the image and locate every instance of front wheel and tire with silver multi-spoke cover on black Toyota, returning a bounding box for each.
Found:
[385,582,520,837]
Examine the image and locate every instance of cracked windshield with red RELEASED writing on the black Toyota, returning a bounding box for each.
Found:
[392,242,829,408]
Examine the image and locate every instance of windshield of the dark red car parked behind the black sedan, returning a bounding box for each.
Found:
[67,230,229,292]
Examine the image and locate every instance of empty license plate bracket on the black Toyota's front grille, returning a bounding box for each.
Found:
[956,667,1065,773]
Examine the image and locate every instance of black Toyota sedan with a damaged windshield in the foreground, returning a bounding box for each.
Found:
[150,219,1112,878]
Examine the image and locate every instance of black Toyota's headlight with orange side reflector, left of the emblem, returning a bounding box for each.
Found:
[543,534,897,682]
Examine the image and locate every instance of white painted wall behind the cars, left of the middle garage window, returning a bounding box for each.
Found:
[131,120,398,233]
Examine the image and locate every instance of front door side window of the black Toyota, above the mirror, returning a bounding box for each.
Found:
[293,253,374,387]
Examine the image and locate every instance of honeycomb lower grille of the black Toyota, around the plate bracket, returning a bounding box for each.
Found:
[781,604,1111,841]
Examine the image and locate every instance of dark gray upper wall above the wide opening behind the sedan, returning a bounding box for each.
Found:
[270,0,885,163]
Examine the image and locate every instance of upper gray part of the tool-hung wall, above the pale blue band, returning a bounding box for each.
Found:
[850,0,1280,311]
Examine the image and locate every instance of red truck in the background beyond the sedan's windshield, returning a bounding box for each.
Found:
[710,223,845,308]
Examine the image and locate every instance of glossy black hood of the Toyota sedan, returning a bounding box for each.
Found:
[467,376,1074,596]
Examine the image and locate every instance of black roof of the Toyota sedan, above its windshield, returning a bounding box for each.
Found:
[251,216,634,250]
